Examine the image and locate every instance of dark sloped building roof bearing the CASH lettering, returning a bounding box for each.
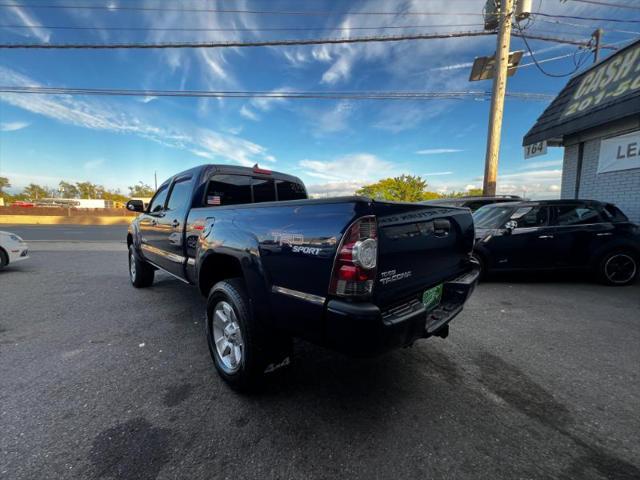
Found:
[522,40,640,145]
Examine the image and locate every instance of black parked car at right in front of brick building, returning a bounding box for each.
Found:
[473,200,640,285]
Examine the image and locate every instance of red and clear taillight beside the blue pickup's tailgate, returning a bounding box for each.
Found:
[329,216,378,297]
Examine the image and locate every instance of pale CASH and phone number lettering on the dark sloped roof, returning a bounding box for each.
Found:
[563,43,640,118]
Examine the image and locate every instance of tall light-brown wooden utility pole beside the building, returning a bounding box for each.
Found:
[482,0,514,195]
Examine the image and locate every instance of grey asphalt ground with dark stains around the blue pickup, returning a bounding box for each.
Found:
[0,226,640,480]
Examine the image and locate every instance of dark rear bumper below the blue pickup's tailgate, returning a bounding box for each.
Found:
[325,263,480,356]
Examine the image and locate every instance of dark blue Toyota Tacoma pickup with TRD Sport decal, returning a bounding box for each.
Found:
[127,165,479,389]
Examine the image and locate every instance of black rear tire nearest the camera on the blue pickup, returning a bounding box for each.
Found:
[206,278,292,392]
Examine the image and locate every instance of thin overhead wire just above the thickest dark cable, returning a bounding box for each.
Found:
[0,23,483,32]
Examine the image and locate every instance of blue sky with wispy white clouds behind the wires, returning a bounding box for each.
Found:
[0,0,640,197]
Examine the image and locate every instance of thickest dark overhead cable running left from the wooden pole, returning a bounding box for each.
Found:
[0,30,496,50]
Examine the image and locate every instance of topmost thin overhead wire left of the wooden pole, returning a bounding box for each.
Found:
[0,3,483,17]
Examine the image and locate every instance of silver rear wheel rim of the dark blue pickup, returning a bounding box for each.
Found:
[213,300,244,373]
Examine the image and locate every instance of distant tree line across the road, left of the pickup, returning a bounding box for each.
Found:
[0,177,154,202]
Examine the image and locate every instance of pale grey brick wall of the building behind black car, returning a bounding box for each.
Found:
[561,124,640,223]
